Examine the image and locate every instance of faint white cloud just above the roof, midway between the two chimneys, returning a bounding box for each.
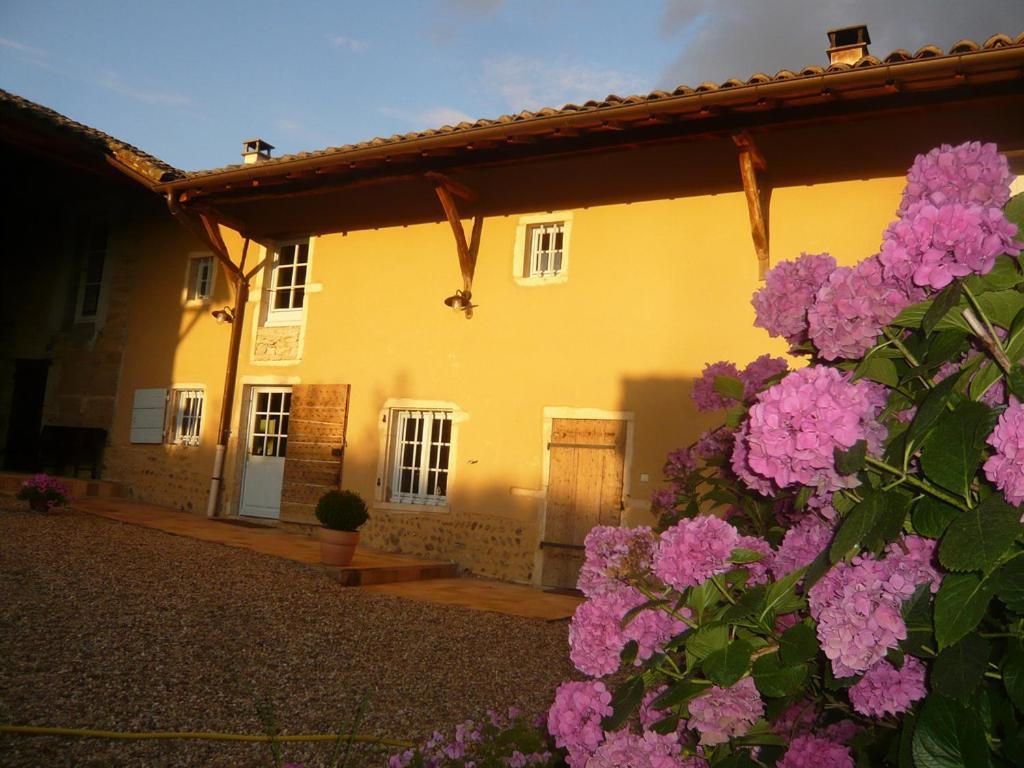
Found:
[483,56,650,112]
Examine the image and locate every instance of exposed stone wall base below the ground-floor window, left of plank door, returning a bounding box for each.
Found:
[361,509,538,584]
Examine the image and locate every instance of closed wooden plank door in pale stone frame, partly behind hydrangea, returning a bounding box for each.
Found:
[541,419,626,589]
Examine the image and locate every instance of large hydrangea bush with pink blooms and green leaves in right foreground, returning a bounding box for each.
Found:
[391,142,1024,768]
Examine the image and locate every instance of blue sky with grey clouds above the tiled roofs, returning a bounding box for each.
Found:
[0,0,1024,169]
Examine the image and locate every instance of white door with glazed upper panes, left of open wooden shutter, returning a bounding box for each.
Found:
[240,387,292,518]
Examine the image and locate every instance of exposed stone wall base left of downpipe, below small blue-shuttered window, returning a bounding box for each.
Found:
[104,444,213,512]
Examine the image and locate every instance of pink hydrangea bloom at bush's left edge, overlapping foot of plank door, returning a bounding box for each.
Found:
[577,528,655,597]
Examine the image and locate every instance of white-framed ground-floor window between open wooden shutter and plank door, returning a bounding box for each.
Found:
[385,409,454,506]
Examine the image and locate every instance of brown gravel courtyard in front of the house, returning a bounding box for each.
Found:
[0,497,572,768]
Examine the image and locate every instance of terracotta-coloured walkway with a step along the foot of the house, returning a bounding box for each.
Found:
[73,497,581,621]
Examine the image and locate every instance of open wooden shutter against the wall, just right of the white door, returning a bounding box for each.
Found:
[281,384,349,523]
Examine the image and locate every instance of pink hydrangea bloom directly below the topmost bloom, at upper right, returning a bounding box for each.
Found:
[880,202,1021,290]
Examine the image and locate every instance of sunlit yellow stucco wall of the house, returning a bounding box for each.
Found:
[108,177,903,582]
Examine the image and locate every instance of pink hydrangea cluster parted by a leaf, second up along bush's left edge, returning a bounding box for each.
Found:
[569,587,687,677]
